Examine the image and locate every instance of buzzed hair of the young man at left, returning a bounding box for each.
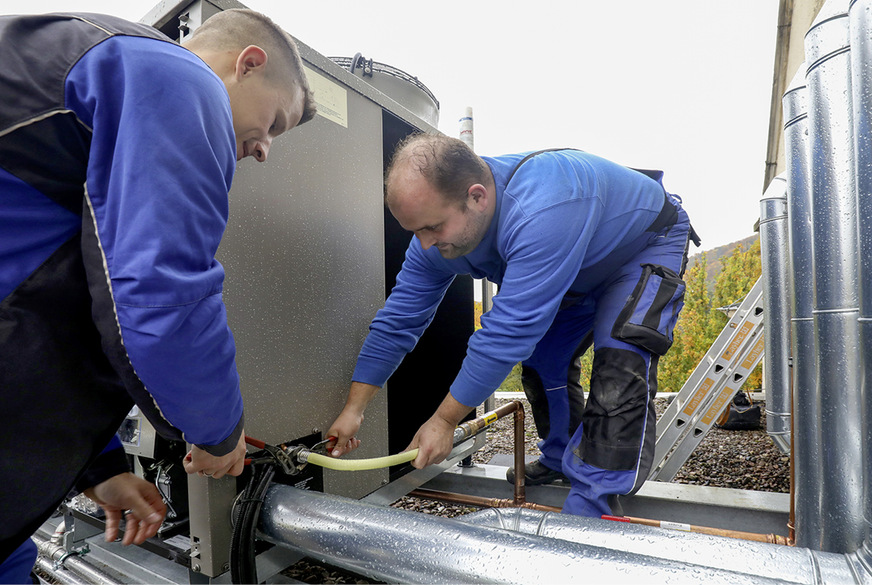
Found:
[185,8,316,125]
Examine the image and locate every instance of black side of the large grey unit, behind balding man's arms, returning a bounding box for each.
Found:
[382,111,475,479]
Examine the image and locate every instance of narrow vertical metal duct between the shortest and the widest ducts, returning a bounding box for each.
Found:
[781,63,824,547]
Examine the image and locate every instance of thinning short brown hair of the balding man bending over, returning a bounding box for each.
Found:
[385,132,489,204]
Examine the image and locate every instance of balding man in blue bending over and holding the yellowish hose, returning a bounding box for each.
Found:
[329,134,696,516]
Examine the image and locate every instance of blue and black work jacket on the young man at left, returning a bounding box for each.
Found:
[0,15,243,455]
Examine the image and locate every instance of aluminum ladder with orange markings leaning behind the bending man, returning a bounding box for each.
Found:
[648,278,763,481]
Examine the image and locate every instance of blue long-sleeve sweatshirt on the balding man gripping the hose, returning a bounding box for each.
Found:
[353,150,664,407]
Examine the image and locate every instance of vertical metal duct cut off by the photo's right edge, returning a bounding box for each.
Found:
[850,0,872,553]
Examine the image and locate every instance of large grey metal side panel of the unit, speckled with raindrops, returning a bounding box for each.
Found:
[218,72,387,497]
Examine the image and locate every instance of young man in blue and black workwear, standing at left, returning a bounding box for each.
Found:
[0,10,314,571]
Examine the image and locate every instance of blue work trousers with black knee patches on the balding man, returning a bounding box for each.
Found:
[522,196,691,517]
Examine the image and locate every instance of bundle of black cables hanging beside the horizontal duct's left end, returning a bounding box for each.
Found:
[230,465,275,583]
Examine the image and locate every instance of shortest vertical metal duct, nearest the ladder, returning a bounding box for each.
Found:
[760,174,791,453]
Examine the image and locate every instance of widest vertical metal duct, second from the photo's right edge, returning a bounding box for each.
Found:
[802,0,865,552]
